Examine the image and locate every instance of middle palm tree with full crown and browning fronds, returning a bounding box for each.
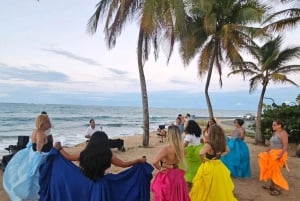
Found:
[180,0,266,118]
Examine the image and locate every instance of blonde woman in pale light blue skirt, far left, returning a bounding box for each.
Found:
[3,114,52,201]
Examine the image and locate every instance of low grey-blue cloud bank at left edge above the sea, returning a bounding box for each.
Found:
[0,63,68,82]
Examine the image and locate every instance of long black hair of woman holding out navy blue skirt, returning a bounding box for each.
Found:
[79,131,112,181]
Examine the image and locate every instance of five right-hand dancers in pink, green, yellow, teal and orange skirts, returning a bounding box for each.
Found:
[151,119,288,201]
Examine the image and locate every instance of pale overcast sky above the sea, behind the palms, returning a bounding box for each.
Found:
[0,0,300,109]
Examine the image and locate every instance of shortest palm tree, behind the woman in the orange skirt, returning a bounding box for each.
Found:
[228,36,300,143]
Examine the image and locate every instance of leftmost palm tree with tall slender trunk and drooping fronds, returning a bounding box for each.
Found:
[88,0,185,146]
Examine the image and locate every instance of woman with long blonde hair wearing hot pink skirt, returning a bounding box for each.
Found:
[151,125,190,201]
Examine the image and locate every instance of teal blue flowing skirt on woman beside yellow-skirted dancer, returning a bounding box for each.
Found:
[221,138,251,178]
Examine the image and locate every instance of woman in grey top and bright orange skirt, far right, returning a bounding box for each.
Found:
[258,120,289,196]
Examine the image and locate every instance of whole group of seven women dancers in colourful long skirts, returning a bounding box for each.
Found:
[3,114,288,201]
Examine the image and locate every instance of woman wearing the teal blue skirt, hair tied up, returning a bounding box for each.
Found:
[221,119,251,178]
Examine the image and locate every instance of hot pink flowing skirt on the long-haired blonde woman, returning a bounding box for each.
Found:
[151,168,190,201]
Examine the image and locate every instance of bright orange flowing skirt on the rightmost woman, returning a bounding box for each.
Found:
[258,149,289,190]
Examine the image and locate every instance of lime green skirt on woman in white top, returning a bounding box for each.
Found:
[184,144,203,183]
